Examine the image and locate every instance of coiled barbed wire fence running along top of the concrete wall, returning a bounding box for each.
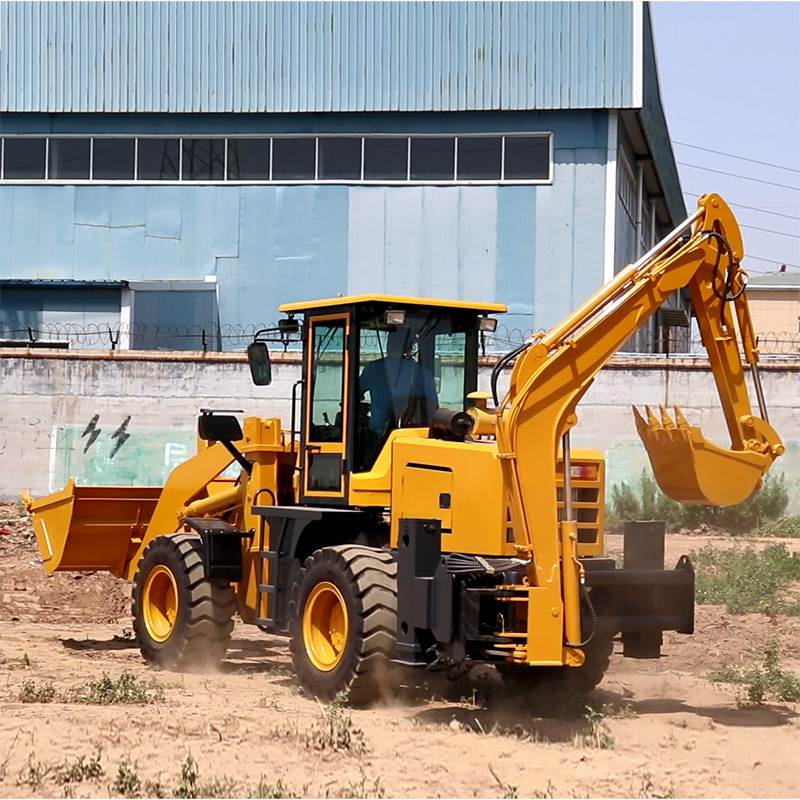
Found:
[0,322,800,359]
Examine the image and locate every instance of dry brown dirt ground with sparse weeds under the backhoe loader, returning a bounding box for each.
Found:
[0,505,800,797]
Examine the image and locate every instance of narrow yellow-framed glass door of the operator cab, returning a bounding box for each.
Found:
[303,314,350,502]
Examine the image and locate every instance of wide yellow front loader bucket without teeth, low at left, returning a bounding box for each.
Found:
[22,481,161,575]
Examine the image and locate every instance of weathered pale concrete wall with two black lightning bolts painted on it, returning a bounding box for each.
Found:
[0,351,800,513]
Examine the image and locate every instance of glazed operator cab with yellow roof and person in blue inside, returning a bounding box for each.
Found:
[251,295,506,505]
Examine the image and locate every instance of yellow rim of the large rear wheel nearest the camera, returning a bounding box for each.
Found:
[303,581,350,672]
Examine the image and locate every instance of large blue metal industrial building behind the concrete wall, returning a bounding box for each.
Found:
[0,2,686,350]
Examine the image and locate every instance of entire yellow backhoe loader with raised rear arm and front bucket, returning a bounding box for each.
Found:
[25,195,783,699]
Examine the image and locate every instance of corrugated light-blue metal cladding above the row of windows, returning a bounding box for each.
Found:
[0,2,636,113]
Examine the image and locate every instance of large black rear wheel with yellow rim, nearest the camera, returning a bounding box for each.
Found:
[289,545,397,704]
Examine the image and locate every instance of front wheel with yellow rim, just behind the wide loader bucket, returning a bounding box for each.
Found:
[132,533,236,672]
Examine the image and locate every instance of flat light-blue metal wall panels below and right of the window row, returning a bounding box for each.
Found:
[0,111,608,335]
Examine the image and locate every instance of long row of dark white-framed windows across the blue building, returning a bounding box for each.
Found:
[0,133,552,184]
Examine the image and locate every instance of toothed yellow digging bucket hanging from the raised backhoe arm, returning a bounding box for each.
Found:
[633,406,772,506]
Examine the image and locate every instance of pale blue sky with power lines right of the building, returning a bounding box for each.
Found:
[650,0,800,277]
